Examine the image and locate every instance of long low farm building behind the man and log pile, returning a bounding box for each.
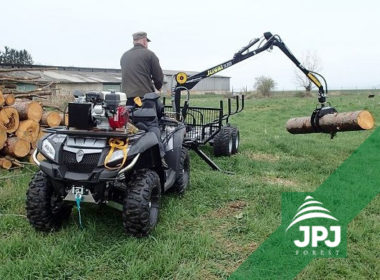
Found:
[0,64,230,94]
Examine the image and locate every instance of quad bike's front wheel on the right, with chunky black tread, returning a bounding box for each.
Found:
[123,169,161,237]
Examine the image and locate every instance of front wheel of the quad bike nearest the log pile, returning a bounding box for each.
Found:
[26,171,72,232]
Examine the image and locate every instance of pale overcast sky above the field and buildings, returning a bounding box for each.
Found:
[0,0,380,91]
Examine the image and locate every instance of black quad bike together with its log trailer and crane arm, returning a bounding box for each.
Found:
[26,32,342,236]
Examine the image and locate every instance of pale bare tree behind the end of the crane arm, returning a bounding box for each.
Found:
[295,51,322,95]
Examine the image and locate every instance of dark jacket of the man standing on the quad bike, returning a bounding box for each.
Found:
[120,44,164,97]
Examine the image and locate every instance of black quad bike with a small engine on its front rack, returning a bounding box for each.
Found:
[26,92,190,236]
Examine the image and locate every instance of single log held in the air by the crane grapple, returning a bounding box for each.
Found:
[286,110,375,134]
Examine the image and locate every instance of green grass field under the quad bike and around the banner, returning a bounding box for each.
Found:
[0,92,380,279]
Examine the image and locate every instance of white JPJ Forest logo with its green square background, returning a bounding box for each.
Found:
[283,193,346,258]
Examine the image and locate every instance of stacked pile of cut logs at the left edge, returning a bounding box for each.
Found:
[0,69,62,169]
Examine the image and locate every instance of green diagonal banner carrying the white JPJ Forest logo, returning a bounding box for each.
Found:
[229,128,380,279]
